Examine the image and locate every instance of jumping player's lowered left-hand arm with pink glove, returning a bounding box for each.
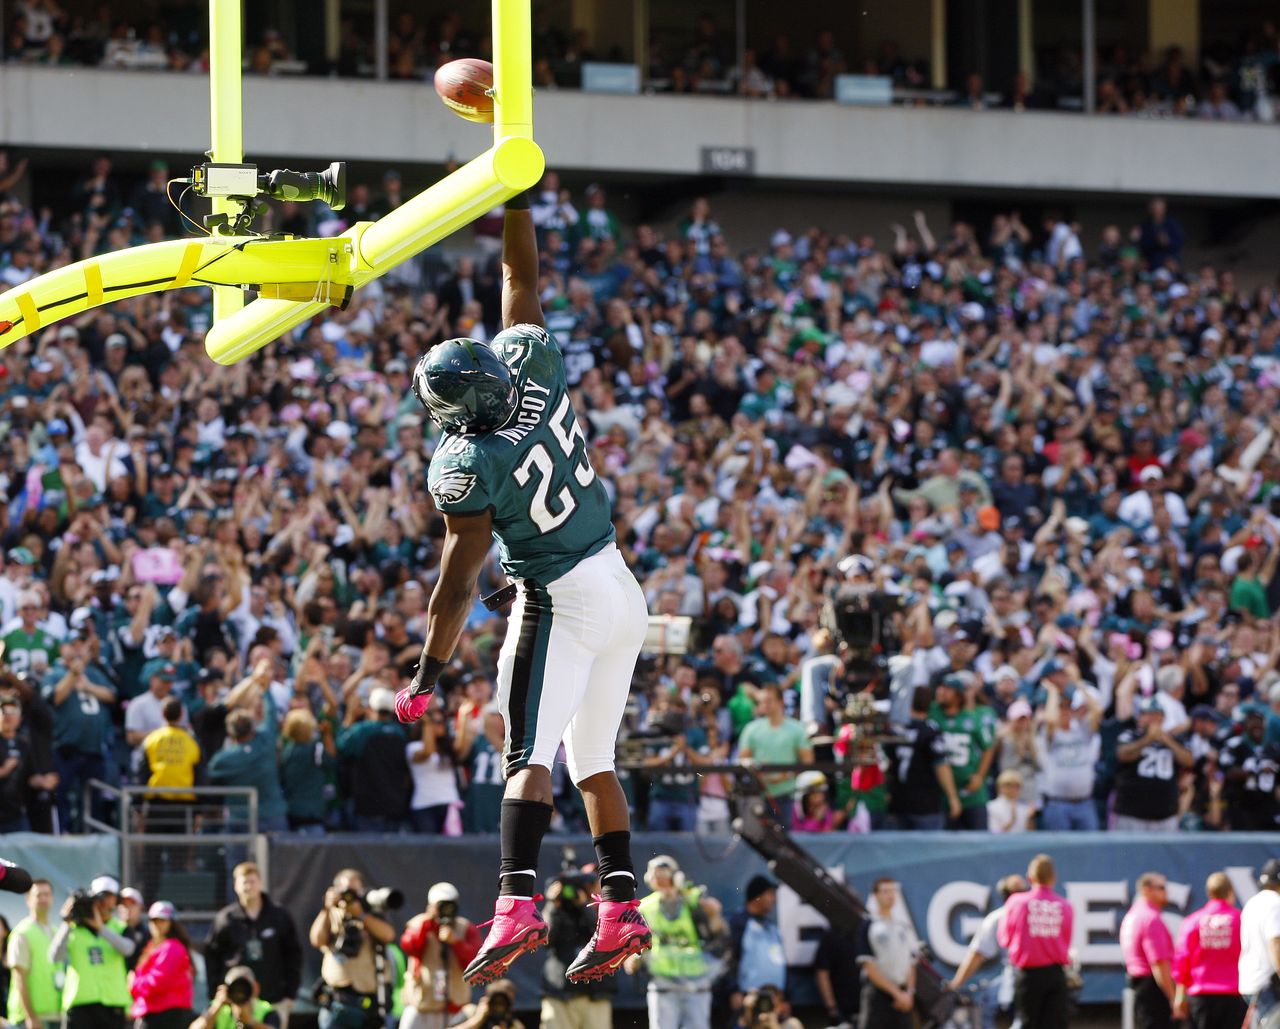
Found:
[396,511,493,722]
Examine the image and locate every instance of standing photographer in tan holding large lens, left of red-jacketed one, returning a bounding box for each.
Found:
[310,868,396,1029]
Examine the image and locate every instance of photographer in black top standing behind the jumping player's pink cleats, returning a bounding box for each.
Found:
[539,847,617,1029]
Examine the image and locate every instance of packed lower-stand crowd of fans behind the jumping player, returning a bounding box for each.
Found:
[0,148,1280,833]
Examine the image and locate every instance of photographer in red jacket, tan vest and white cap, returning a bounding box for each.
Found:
[399,883,481,1029]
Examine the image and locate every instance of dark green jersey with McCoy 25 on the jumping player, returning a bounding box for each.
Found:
[428,325,613,585]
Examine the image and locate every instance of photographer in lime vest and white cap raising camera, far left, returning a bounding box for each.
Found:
[49,875,134,1029]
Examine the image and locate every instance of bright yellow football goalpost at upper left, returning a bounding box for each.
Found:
[0,0,544,365]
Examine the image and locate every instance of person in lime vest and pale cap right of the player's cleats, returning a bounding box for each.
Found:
[623,854,728,1029]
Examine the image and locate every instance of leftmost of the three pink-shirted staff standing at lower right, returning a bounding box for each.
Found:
[997,854,1075,1029]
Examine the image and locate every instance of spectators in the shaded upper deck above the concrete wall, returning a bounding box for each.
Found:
[0,0,1280,122]
